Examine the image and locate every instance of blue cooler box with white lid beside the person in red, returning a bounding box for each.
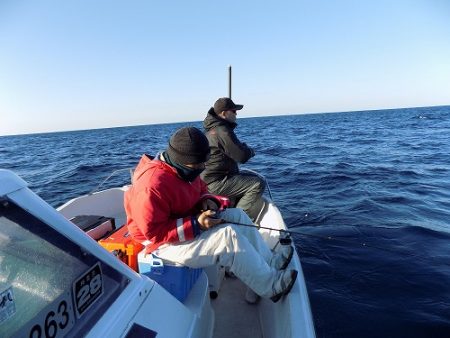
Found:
[138,249,203,302]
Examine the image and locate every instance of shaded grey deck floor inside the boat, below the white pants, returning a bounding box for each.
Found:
[211,277,263,338]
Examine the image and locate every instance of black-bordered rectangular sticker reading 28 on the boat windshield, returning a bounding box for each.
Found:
[73,262,103,318]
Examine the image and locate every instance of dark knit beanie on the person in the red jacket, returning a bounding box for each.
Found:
[167,127,209,164]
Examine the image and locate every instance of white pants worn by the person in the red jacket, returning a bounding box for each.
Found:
[154,208,276,297]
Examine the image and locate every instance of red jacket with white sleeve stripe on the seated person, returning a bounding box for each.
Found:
[124,154,208,252]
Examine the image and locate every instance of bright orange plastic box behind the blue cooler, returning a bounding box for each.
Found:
[98,225,144,272]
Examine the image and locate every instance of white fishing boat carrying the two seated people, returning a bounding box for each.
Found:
[0,170,315,338]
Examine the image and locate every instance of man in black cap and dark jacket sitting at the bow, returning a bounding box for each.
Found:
[202,97,266,222]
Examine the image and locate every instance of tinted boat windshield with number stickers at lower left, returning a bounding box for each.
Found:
[0,200,128,338]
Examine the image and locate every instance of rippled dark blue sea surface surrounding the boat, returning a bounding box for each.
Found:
[0,107,450,338]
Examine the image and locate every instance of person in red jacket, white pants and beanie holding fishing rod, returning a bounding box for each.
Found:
[125,127,297,302]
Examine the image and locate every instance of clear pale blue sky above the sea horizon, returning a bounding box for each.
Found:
[0,0,450,135]
